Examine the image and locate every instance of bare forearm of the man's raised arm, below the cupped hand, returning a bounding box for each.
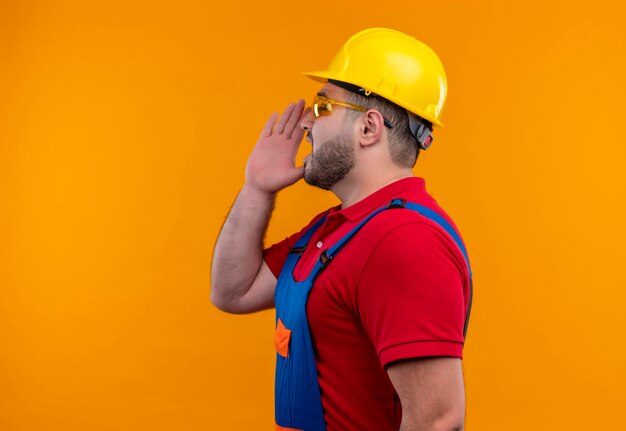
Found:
[211,186,274,309]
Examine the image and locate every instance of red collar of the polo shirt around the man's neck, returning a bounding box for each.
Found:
[328,177,426,221]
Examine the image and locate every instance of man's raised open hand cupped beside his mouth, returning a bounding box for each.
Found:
[246,100,310,194]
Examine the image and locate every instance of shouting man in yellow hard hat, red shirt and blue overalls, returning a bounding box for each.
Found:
[211,29,471,431]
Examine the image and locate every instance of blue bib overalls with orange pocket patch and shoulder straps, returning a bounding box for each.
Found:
[274,199,472,431]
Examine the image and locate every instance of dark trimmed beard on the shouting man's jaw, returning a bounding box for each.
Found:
[304,130,355,190]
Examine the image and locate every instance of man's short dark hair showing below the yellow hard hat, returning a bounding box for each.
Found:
[345,90,432,168]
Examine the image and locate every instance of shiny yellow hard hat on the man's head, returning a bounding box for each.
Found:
[305,28,448,126]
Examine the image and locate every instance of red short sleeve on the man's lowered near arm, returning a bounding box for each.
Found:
[357,221,469,367]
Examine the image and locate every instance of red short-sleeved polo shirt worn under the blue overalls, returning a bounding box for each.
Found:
[264,177,469,431]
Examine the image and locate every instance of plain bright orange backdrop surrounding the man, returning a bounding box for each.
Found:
[0,0,626,431]
